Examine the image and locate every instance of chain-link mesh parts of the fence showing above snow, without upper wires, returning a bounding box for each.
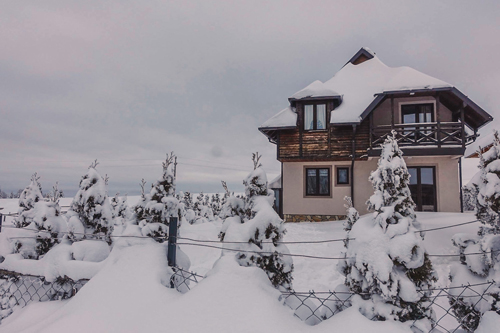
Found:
[0,258,496,333]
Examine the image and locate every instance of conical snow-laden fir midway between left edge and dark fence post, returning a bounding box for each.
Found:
[66,160,113,242]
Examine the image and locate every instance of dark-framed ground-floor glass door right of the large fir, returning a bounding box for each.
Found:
[408,166,437,212]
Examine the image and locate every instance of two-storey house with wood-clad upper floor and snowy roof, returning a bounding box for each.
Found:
[259,48,492,221]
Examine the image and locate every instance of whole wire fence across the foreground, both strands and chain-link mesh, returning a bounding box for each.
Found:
[0,211,496,332]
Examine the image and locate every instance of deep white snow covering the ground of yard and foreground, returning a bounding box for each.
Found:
[0,198,490,332]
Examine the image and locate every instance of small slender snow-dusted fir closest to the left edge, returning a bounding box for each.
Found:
[14,172,43,228]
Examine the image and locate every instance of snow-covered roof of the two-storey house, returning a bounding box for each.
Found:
[260,48,492,138]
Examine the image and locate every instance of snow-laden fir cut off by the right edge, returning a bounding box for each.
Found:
[449,131,500,331]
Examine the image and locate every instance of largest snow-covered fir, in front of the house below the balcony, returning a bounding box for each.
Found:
[338,136,435,332]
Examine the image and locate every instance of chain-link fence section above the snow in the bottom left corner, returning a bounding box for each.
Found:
[0,270,88,322]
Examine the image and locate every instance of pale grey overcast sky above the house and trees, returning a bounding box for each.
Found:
[0,0,500,195]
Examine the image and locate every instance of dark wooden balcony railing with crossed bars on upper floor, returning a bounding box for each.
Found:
[370,122,475,148]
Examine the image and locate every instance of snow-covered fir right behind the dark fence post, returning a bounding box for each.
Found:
[134,152,184,242]
